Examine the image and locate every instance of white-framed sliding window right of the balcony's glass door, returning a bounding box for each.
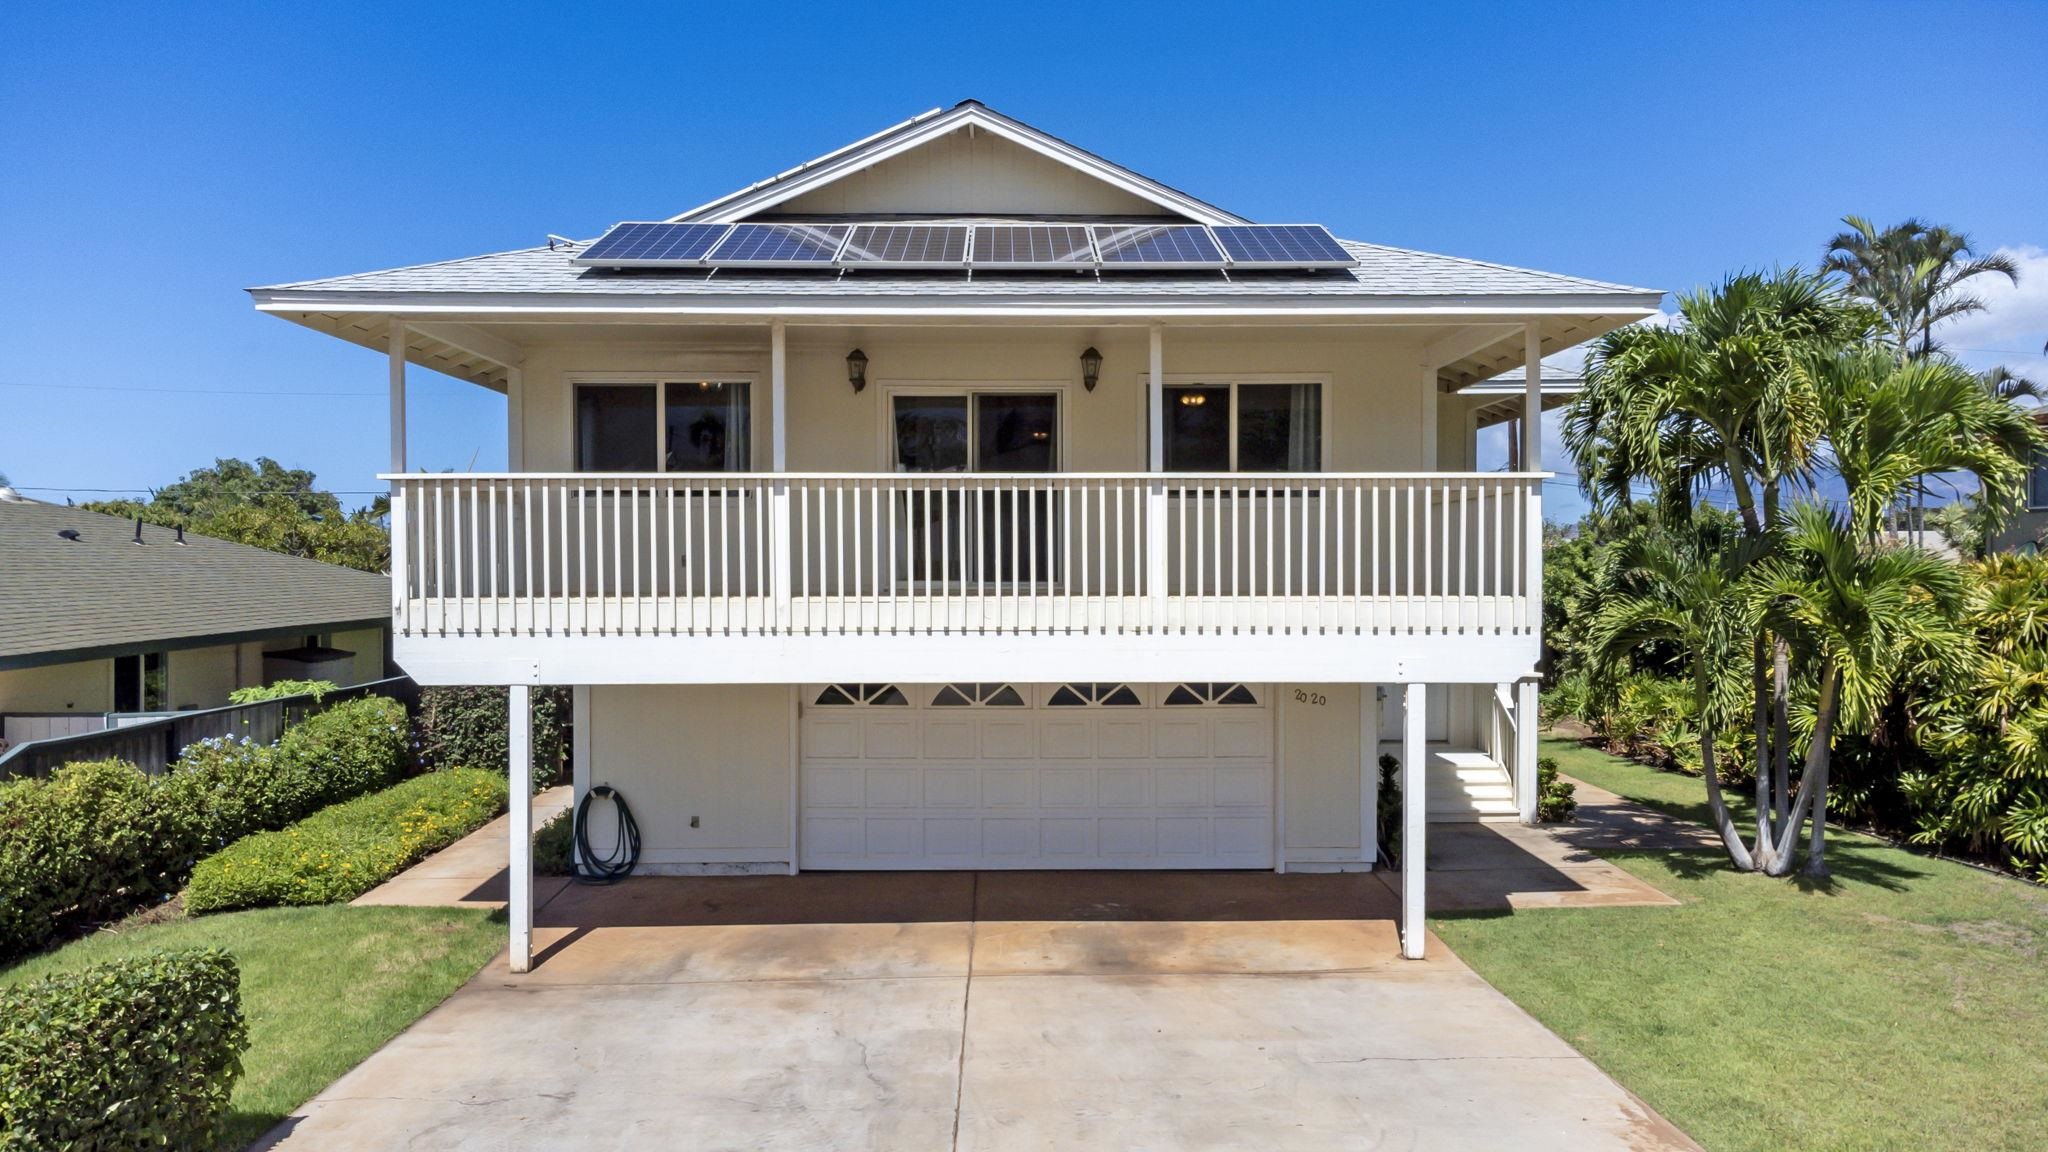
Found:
[1163,381,1323,471]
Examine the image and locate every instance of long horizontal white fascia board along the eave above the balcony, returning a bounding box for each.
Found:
[256,293,1657,324]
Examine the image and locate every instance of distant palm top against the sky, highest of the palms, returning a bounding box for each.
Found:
[1821,215,2019,357]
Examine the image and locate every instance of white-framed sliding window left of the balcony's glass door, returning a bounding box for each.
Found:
[575,379,754,471]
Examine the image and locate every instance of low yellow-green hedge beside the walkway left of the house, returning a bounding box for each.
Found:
[184,769,507,912]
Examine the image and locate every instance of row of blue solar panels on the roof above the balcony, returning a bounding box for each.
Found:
[573,221,1358,271]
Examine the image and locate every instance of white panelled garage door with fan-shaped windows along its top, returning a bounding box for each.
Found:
[799,685,1274,869]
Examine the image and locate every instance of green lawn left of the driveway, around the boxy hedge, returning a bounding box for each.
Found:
[0,904,504,1148]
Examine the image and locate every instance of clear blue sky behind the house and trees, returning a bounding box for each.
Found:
[0,2,2048,516]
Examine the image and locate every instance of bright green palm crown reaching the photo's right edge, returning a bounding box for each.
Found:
[1802,346,2048,541]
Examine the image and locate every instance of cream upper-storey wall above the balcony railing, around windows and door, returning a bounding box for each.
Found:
[514,328,1441,471]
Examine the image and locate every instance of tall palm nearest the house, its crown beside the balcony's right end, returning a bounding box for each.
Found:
[1565,271,1878,869]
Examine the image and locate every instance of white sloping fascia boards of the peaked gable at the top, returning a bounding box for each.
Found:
[668,105,1249,223]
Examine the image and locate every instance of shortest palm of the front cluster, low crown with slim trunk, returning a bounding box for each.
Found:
[1753,504,1970,877]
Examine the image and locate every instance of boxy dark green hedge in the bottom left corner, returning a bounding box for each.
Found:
[0,949,248,1152]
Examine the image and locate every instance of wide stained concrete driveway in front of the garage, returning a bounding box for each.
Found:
[270,873,1694,1152]
